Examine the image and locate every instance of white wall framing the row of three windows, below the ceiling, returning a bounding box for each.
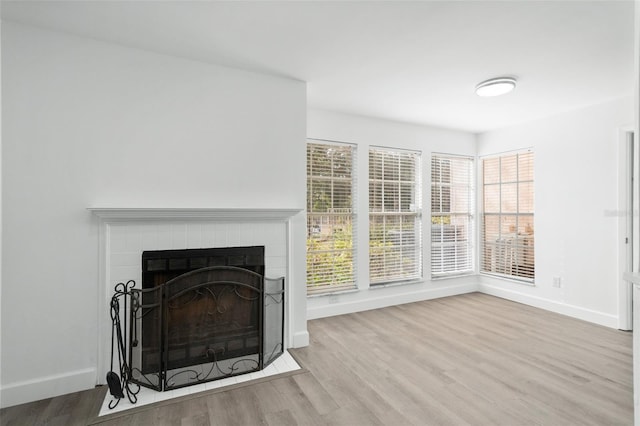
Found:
[307,109,477,319]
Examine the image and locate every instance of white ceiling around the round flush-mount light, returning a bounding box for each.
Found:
[1,0,634,133]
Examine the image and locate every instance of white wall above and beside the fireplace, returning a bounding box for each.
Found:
[1,22,306,406]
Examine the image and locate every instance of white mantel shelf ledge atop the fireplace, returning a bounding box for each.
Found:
[88,207,302,221]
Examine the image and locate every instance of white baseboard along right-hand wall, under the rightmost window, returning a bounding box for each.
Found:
[479,282,618,329]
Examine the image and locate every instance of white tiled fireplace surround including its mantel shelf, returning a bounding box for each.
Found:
[89,208,301,384]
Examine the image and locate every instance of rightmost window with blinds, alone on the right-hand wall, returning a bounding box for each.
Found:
[481,152,535,282]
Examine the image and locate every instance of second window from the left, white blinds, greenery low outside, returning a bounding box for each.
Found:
[369,148,422,285]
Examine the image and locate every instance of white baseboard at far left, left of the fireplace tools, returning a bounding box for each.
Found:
[0,368,96,408]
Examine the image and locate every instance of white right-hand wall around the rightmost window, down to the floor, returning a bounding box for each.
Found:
[478,97,634,327]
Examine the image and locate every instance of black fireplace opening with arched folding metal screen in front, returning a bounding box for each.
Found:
[124,247,284,390]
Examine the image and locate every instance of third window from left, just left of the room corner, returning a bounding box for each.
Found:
[431,155,474,278]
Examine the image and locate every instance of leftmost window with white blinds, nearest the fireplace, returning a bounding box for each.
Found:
[307,142,355,295]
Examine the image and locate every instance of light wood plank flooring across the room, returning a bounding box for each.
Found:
[0,293,633,426]
